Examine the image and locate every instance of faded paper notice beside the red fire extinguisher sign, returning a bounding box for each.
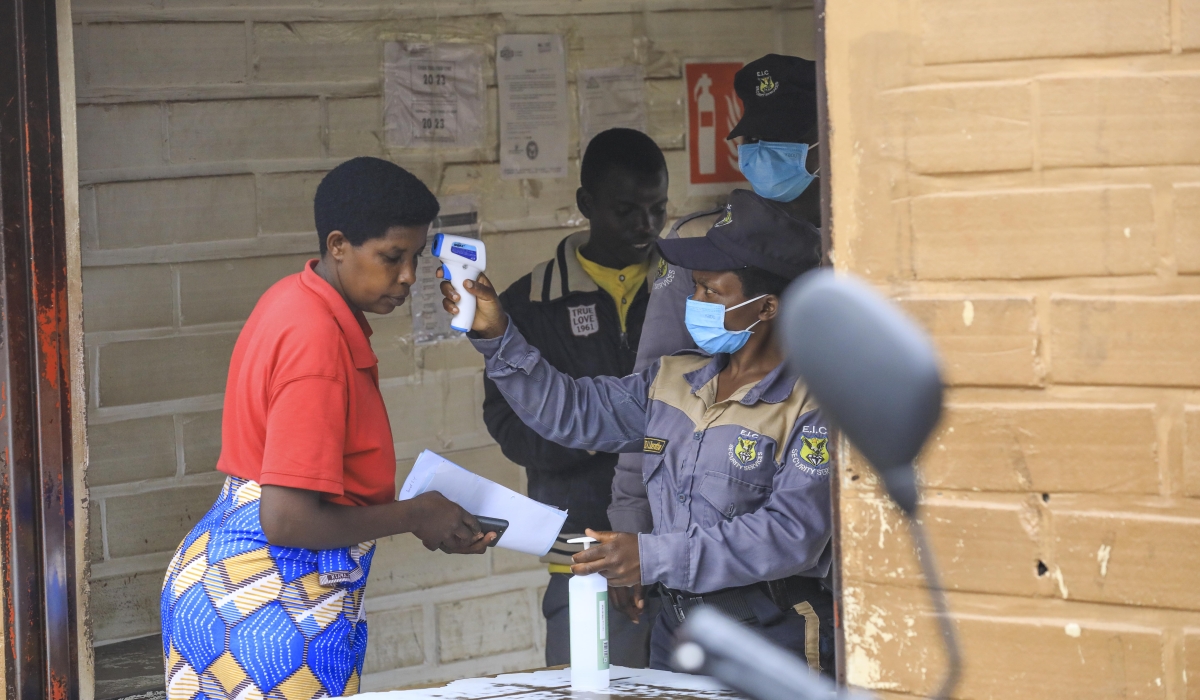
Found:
[575,66,647,157]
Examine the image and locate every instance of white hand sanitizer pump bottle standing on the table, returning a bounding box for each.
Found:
[568,537,608,690]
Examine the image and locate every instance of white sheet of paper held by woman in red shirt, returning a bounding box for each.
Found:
[396,450,566,557]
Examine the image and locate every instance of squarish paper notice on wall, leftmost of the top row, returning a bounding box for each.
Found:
[383,41,486,148]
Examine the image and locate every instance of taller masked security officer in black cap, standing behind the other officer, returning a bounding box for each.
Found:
[608,54,821,629]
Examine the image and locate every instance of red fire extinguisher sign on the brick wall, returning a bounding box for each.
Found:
[684,60,746,195]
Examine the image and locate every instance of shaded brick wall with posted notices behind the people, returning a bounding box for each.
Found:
[73,0,816,688]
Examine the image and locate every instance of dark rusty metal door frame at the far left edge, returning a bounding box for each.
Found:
[0,0,90,700]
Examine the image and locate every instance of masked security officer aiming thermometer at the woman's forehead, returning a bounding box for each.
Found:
[442,190,833,671]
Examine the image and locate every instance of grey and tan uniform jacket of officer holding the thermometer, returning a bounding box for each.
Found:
[472,323,832,593]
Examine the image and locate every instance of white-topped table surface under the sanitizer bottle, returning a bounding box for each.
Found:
[355,666,740,700]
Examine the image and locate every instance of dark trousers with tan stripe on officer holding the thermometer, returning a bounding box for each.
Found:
[650,591,834,678]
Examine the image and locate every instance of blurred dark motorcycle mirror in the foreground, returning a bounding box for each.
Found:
[780,270,942,516]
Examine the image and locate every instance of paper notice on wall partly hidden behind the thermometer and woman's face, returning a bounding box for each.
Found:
[409,195,479,345]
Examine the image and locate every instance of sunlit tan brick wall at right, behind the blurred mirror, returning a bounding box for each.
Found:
[826,0,1200,700]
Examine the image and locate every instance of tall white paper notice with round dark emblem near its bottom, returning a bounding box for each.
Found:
[496,34,570,180]
